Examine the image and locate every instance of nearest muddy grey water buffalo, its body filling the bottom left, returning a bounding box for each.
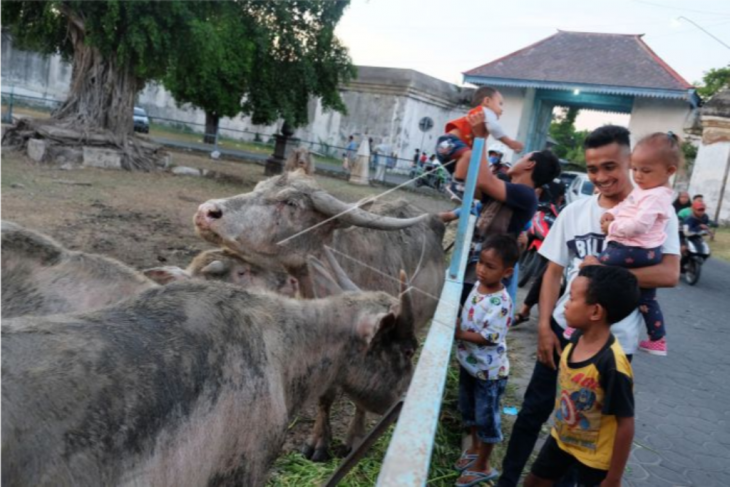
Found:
[2,281,413,487]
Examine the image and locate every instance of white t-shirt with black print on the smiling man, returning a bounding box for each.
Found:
[540,195,680,354]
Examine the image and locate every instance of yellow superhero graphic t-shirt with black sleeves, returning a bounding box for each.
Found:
[552,332,634,470]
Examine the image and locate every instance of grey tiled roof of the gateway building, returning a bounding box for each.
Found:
[464,31,692,92]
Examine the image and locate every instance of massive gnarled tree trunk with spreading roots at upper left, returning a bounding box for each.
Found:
[2,4,166,170]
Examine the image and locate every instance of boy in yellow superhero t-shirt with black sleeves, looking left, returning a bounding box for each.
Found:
[525,266,639,487]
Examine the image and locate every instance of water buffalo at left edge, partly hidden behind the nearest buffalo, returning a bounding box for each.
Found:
[2,221,296,318]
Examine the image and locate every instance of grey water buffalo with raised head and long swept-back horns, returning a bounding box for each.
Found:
[194,171,445,328]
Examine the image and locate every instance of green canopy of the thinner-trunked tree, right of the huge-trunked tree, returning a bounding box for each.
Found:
[163,0,355,141]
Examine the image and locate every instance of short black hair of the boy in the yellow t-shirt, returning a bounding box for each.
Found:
[578,265,640,325]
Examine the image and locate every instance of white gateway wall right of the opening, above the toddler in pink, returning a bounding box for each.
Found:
[629,98,692,144]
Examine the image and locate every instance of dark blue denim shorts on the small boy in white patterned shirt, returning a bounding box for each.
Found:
[459,366,507,443]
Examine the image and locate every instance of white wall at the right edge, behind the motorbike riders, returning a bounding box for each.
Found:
[689,142,730,224]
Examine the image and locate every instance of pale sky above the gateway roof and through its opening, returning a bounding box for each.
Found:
[337,0,730,129]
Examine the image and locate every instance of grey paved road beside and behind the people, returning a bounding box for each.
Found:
[510,259,730,487]
